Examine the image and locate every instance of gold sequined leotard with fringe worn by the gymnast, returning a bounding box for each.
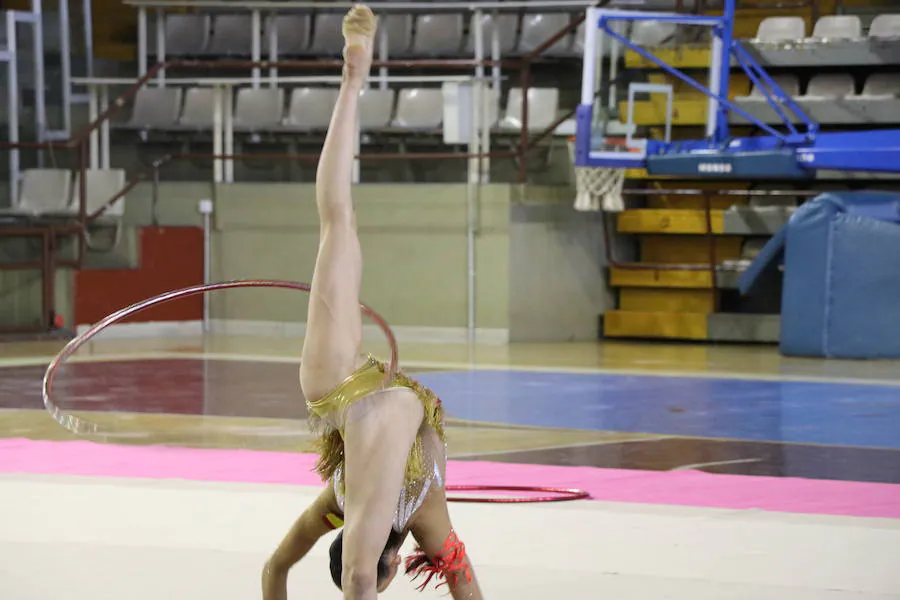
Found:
[306,355,446,531]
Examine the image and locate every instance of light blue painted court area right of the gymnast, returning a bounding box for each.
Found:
[417,371,900,448]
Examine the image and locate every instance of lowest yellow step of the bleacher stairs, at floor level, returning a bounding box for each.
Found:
[603,310,709,340]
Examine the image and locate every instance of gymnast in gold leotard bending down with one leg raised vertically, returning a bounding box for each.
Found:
[262,5,482,600]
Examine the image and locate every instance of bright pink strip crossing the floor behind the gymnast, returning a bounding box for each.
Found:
[0,439,900,519]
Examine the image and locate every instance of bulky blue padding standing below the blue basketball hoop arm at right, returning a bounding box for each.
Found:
[740,192,900,358]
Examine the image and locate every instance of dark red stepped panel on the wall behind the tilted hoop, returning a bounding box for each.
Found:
[75,227,203,325]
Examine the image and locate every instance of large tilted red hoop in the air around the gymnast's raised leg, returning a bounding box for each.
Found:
[41,279,398,437]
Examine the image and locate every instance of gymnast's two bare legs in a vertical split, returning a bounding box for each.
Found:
[300,5,424,600]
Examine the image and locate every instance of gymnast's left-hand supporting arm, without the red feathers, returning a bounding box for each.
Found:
[262,485,340,600]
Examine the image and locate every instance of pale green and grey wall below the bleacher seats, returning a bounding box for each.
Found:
[0,182,612,341]
